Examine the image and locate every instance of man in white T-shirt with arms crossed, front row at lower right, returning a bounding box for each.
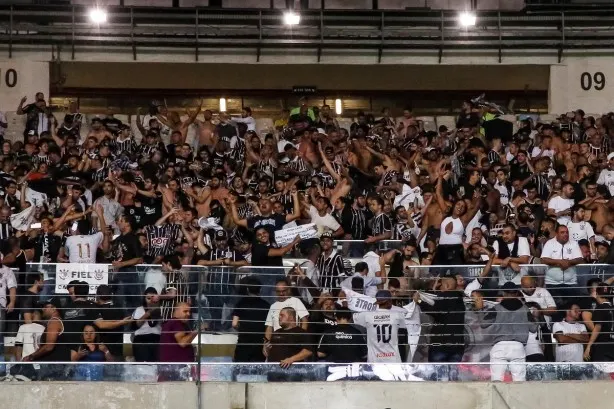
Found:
[552,303,589,362]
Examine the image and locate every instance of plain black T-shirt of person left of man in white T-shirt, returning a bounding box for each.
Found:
[232,296,271,345]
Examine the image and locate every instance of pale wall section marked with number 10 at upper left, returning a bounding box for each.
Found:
[0,60,49,112]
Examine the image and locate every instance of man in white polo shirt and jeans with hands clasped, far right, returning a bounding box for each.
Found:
[541,225,584,298]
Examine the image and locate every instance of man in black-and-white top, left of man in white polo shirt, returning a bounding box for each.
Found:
[492,223,531,286]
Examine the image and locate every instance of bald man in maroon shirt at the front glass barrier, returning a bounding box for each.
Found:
[160,303,205,362]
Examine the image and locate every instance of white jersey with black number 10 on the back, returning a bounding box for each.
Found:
[355,309,407,363]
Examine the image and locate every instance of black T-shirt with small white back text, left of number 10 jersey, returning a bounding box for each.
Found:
[318,324,367,363]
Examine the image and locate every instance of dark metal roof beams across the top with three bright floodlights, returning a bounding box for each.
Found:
[0,6,614,62]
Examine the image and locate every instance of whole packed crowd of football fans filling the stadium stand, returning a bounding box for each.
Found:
[0,93,614,379]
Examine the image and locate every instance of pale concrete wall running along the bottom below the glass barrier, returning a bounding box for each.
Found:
[0,381,614,409]
